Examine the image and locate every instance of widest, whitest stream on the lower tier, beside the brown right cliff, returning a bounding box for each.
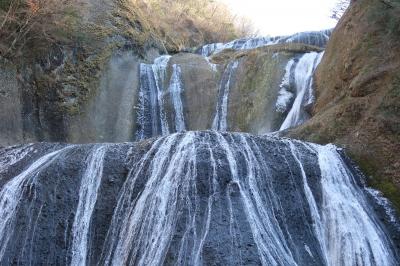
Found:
[314,145,395,266]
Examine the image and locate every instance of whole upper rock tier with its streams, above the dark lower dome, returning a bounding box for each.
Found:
[136,45,323,140]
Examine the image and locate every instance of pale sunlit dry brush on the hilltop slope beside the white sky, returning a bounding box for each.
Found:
[130,0,254,50]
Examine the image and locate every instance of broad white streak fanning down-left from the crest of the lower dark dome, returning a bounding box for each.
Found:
[104,132,195,265]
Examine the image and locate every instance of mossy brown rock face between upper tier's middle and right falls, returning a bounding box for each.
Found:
[228,52,293,134]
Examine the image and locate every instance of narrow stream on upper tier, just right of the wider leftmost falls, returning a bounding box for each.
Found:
[169,64,186,132]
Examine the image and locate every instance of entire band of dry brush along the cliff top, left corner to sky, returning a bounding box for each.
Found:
[0,0,253,58]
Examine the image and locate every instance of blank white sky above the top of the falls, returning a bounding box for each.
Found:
[220,0,337,36]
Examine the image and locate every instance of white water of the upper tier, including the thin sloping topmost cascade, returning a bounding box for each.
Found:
[136,30,331,136]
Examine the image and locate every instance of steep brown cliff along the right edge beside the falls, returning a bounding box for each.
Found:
[287,0,400,212]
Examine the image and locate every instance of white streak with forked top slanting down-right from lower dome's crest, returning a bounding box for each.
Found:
[218,135,297,265]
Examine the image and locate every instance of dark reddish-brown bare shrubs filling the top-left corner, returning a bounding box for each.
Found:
[0,0,80,58]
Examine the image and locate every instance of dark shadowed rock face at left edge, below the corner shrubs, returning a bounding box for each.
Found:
[0,49,71,145]
